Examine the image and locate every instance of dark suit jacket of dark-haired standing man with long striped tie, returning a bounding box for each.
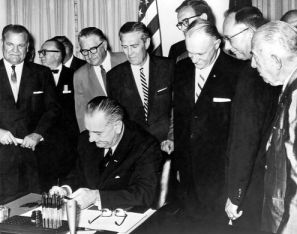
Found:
[107,56,174,142]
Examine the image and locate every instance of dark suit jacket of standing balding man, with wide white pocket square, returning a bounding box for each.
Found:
[173,51,239,216]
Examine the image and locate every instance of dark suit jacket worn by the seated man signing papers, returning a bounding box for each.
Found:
[72,122,161,209]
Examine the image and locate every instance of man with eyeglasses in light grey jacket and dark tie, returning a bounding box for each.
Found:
[74,27,126,132]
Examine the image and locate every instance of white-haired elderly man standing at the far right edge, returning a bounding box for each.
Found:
[252,21,297,234]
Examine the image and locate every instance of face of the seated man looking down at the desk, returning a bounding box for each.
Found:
[85,111,122,149]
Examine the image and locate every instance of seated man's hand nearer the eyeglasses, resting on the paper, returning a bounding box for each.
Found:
[69,188,98,209]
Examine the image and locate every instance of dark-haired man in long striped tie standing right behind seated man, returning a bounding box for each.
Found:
[107,22,174,142]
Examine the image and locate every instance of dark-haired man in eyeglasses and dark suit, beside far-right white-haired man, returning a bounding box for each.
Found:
[223,7,280,230]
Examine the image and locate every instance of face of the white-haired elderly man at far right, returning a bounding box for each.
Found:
[252,41,282,86]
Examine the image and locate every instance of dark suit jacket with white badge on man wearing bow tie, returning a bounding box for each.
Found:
[38,66,79,191]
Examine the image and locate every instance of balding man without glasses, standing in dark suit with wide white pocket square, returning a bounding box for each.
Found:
[173,19,239,224]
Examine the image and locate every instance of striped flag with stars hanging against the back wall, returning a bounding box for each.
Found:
[138,0,162,55]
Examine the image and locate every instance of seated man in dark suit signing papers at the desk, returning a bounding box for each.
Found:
[50,96,161,209]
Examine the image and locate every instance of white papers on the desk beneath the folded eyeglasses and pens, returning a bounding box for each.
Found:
[22,207,156,234]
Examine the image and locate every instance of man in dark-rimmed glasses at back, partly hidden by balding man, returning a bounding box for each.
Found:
[168,0,215,62]
